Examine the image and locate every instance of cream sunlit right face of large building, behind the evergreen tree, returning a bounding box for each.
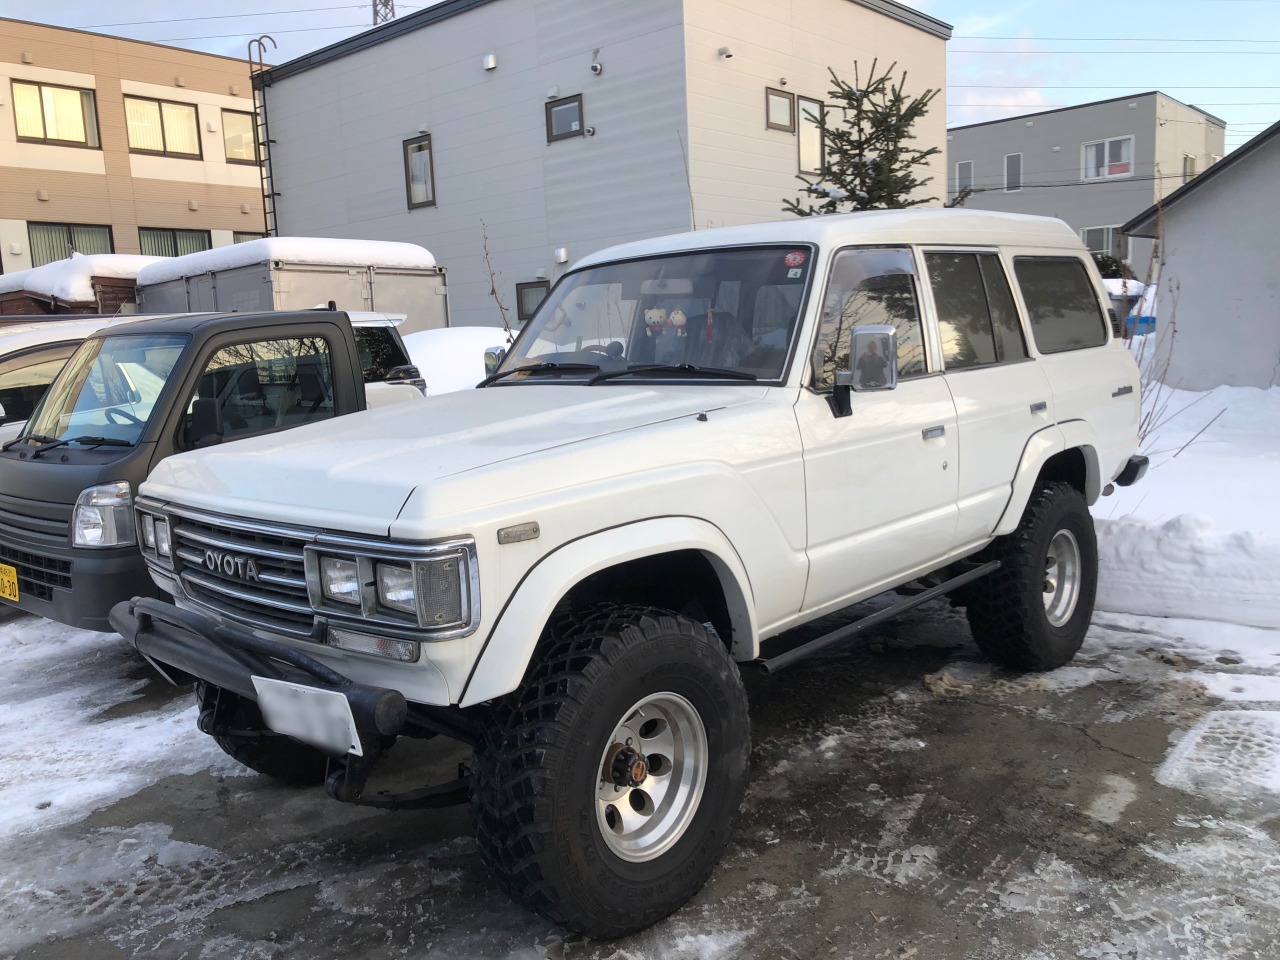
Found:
[685,0,950,229]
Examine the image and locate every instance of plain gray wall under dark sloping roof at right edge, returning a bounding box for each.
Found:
[1156,138,1280,391]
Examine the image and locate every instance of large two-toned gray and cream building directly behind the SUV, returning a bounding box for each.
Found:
[260,0,951,324]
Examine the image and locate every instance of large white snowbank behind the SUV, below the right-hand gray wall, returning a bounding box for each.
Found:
[1093,378,1280,628]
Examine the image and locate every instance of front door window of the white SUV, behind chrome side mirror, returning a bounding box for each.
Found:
[813,247,927,390]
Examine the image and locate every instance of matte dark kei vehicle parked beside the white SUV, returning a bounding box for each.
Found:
[0,310,422,630]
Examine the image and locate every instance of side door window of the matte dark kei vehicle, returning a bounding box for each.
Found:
[187,337,334,440]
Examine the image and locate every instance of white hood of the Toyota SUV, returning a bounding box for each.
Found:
[141,384,764,536]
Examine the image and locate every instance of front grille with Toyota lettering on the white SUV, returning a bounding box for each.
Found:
[170,512,315,635]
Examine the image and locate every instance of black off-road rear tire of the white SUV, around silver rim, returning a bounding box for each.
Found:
[964,481,1098,671]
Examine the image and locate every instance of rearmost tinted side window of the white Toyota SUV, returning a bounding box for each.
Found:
[1014,257,1107,353]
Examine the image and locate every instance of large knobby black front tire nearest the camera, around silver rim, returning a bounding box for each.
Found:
[471,604,751,938]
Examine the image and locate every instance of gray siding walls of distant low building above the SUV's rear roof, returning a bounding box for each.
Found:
[947,95,1224,278]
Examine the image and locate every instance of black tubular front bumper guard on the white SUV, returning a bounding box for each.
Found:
[110,596,470,810]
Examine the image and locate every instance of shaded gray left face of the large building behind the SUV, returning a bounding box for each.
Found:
[258,0,691,324]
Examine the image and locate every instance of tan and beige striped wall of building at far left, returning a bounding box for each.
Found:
[0,19,264,273]
